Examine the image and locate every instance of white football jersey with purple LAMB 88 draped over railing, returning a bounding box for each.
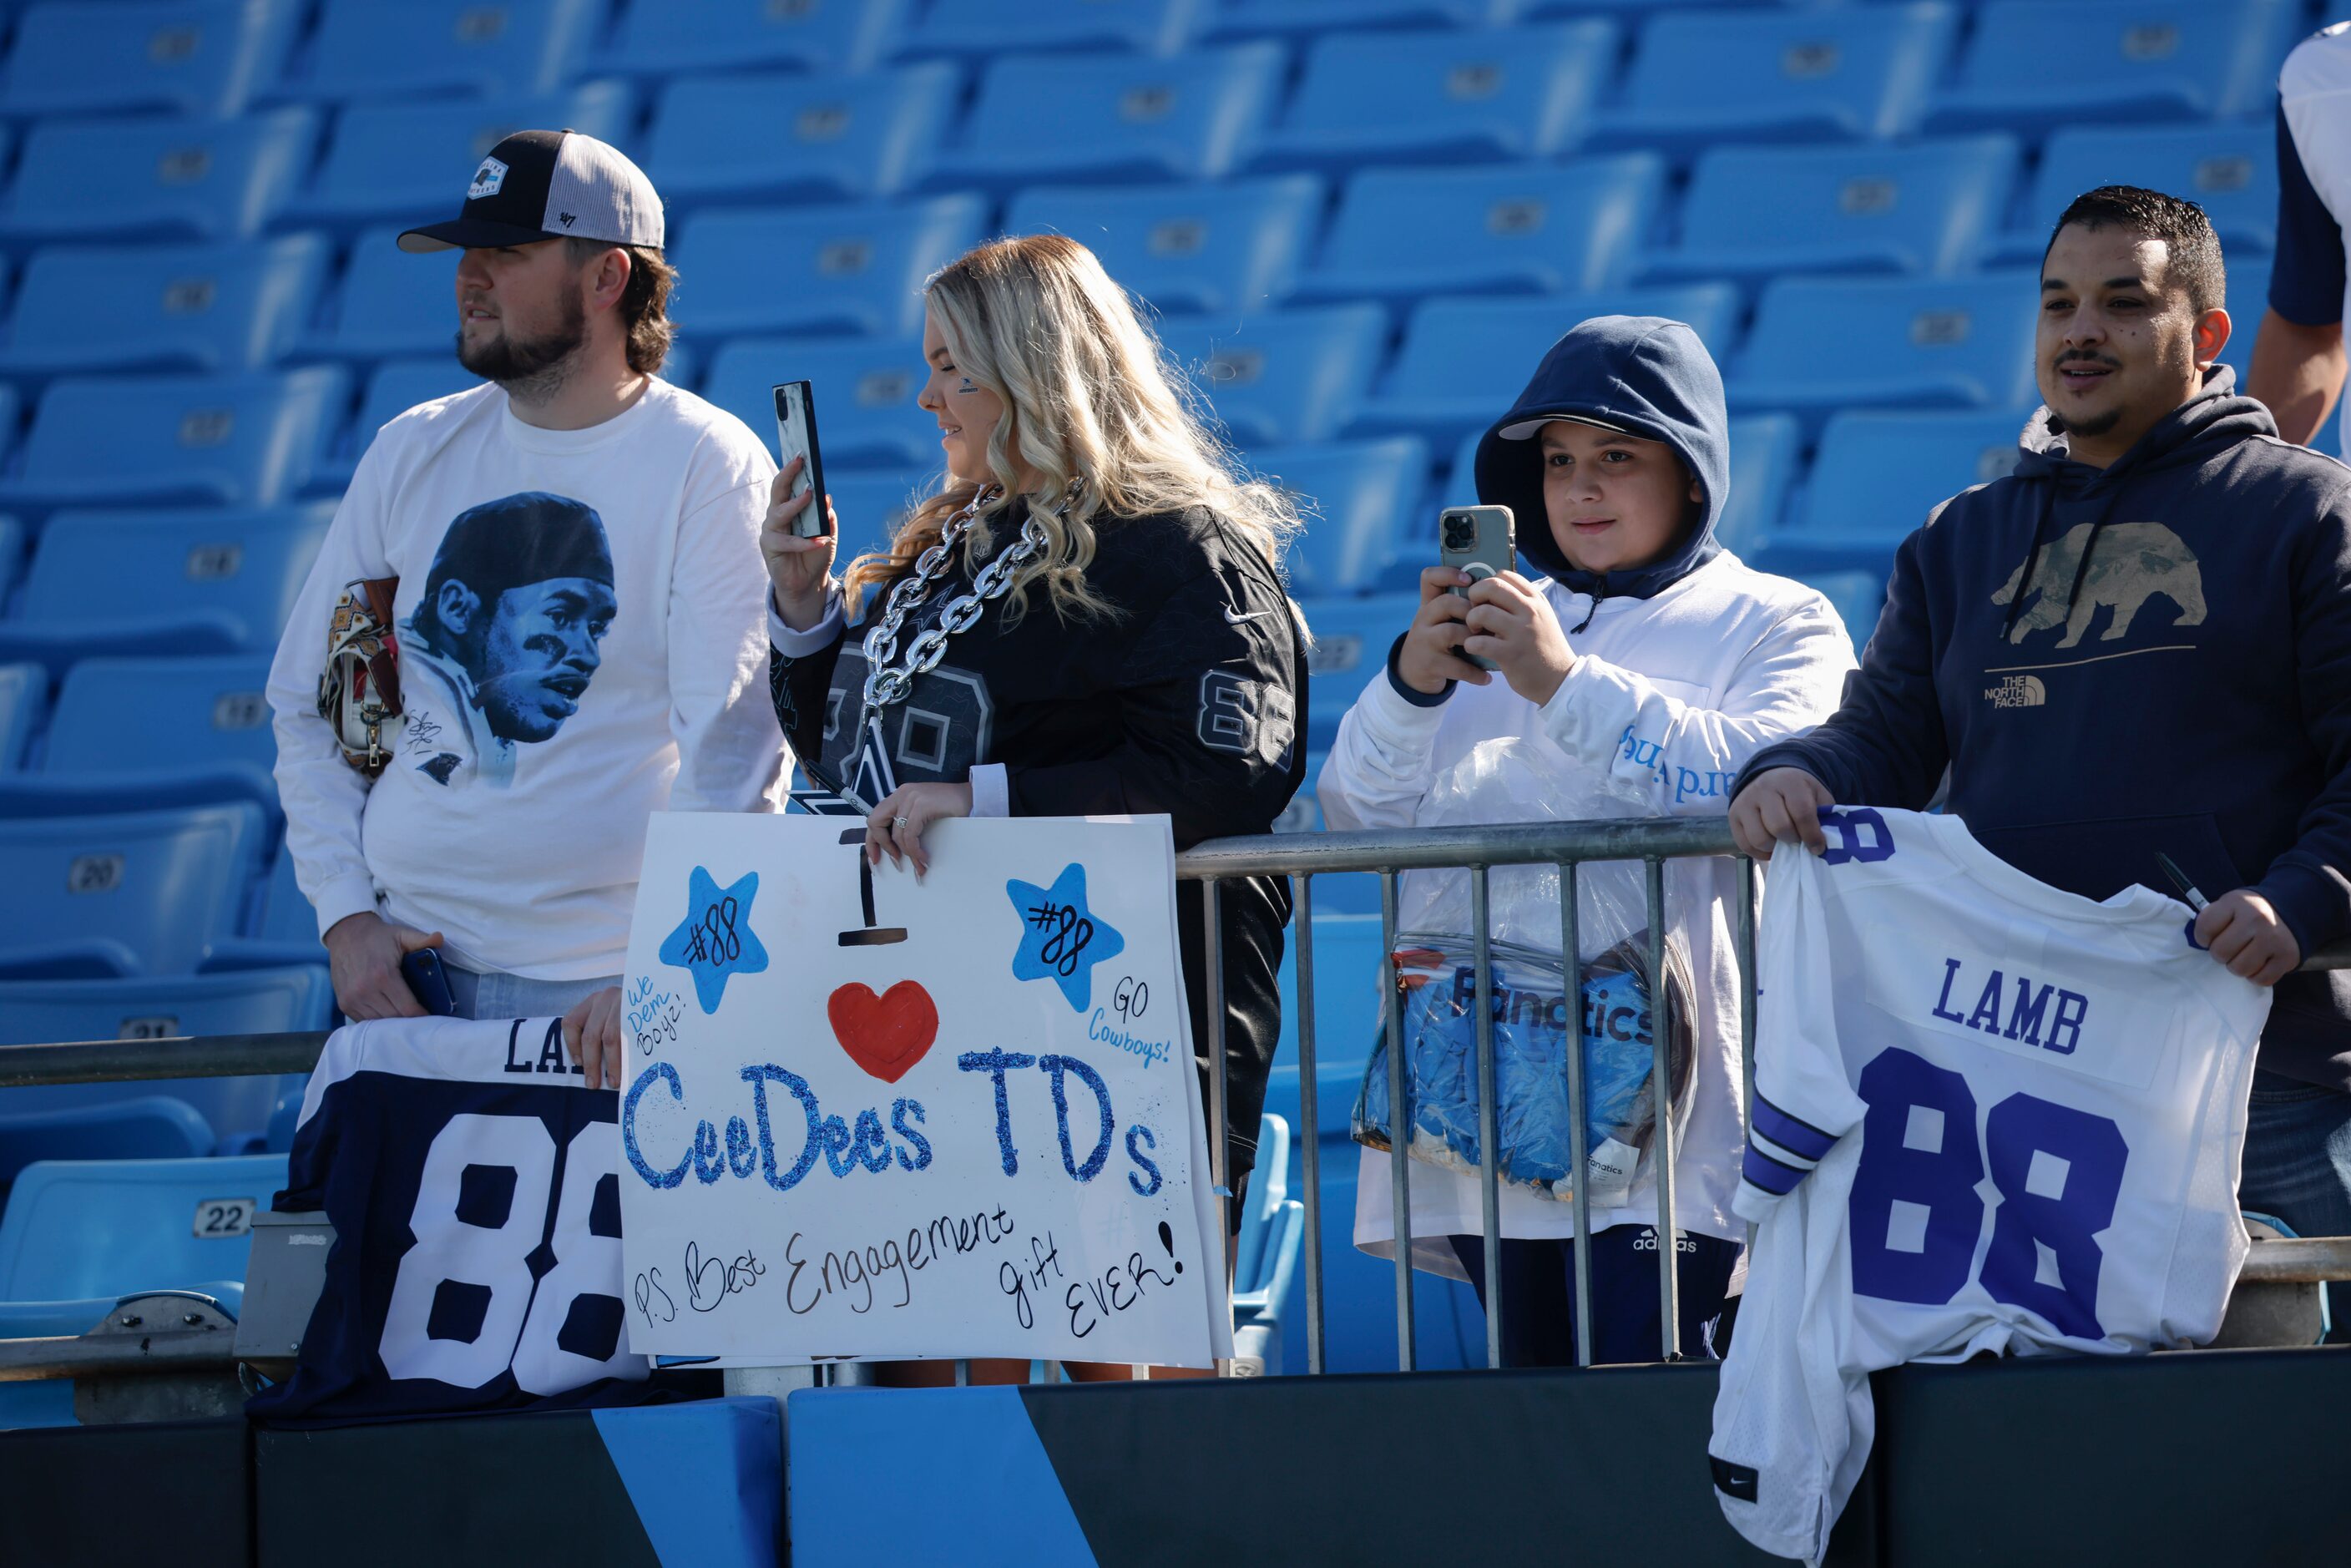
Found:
[1709,809,2268,1561]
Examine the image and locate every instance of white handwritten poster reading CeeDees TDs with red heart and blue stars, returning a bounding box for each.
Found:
[620,813,1232,1366]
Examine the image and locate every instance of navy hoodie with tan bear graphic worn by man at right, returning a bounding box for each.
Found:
[1740,367,2351,1089]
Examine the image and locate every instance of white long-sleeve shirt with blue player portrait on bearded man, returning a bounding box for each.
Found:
[270,381,790,980]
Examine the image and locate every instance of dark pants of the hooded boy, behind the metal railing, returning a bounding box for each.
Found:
[1449,1225,1740,1366]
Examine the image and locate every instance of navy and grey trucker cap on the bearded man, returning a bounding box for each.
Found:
[400,132,663,251]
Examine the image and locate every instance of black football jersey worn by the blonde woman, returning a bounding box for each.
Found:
[769,503,1307,1178]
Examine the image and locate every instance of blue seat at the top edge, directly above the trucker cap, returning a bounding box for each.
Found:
[285,0,604,99]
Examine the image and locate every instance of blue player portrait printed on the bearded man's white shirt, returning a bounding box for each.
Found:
[400,491,619,787]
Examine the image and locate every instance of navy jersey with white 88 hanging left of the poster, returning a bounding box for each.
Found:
[249,1018,649,1420]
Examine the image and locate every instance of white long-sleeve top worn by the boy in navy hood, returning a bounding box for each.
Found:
[1317,550,1855,1277]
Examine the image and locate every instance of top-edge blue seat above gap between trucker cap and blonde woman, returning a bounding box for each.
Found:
[597,0,914,75]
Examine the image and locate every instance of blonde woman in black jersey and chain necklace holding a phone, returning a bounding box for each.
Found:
[564,235,1307,1383]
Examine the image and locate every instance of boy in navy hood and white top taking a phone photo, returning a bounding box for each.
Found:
[1319,315,1853,1366]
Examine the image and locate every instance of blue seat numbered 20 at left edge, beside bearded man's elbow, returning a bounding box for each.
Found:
[0,804,268,978]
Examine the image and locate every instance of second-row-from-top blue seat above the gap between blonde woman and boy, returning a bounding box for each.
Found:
[1256,21,1617,169]
